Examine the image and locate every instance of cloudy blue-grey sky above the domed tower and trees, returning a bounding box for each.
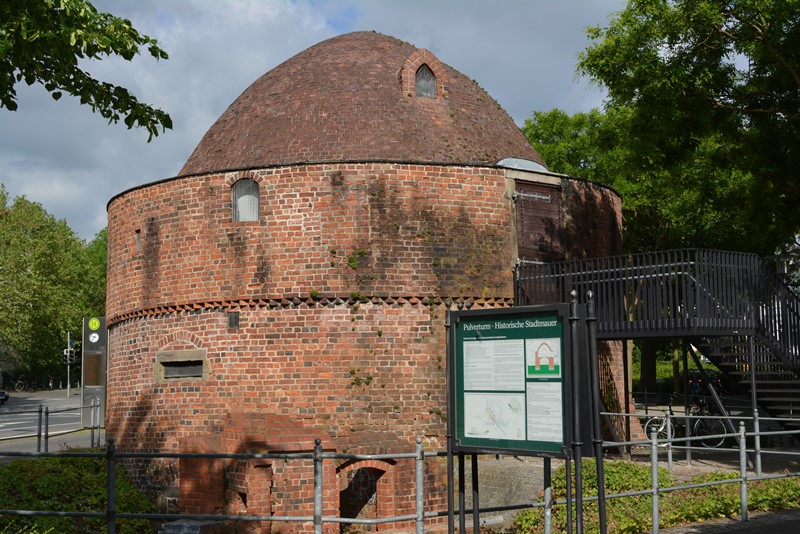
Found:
[0,0,625,241]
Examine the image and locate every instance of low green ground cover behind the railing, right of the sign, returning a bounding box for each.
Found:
[505,459,800,534]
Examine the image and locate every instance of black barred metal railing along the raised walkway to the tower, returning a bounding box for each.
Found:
[515,249,800,369]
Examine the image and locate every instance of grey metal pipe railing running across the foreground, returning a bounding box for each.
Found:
[0,428,800,534]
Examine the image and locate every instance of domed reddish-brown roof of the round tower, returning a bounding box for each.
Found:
[180,32,542,175]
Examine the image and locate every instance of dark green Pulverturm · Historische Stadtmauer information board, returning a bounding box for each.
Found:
[447,304,573,457]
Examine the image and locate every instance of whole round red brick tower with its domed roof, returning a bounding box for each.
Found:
[106,32,621,532]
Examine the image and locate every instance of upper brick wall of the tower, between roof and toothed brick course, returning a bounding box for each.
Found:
[107,164,513,323]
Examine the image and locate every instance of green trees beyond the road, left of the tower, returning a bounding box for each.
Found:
[0,185,105,380]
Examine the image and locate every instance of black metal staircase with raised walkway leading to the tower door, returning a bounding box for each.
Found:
[515,249,800,417]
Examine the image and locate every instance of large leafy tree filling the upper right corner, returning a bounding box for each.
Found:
[568,0,800,255]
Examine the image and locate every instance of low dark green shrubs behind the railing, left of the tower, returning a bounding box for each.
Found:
[0,456,157,534]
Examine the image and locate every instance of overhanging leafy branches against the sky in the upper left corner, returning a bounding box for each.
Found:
[0,0,172,141]
